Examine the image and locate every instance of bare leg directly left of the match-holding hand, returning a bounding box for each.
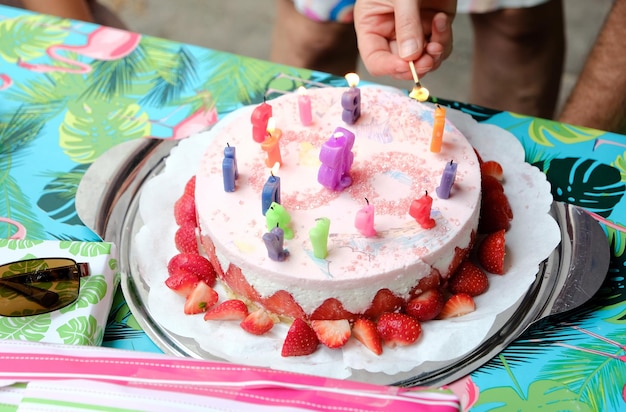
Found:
[270,0,358,76]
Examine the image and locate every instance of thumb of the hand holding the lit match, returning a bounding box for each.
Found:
[394,0,424,61]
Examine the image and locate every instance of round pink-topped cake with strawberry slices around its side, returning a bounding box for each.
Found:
[195,87,481,320]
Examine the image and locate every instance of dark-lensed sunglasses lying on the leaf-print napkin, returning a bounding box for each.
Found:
[0,258,89,317]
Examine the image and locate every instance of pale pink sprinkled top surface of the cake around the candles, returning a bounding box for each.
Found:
[196,87,480,282]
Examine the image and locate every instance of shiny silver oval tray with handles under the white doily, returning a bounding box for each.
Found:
[76,134,609,386]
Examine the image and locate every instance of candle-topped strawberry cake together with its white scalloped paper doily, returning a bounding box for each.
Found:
[134,83,560,383]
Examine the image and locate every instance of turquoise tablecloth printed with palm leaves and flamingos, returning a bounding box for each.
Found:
[0,7,626,411]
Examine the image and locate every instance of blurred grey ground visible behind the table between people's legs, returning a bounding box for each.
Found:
[100,0,608,114]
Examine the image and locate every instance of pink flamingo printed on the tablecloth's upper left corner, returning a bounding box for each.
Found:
[18,26,141,74]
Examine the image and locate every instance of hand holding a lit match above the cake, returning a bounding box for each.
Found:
[354,0,457,80]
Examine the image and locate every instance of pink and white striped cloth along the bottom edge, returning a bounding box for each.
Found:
[0,341,459,412]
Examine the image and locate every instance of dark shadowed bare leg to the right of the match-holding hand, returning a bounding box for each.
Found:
[469,0,565,118]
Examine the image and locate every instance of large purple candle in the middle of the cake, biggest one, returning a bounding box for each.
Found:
[317,127,355,190]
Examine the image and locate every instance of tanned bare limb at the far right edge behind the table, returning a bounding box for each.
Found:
[559,0,626,133]
